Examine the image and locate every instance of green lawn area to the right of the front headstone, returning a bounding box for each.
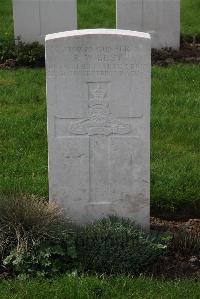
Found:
[151,65,200,216]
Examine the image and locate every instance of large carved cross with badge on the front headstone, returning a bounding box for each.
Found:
[55,82,141,204]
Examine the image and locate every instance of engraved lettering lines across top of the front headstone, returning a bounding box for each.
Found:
[47,45,149,77]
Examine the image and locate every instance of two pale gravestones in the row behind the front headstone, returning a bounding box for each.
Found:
[13,0,180,49]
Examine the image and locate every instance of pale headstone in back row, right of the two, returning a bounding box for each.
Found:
[117,0,180,49]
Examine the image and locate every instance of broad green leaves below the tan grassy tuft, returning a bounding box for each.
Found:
[3,243,76,278]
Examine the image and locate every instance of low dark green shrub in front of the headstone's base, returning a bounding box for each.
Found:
[76,216,171,274]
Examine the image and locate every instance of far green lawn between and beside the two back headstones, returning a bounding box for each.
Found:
[0,0,200,39]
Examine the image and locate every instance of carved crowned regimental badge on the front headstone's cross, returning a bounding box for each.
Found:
[70,82,130,136]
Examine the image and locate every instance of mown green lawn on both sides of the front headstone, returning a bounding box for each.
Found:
[0,65,200,216]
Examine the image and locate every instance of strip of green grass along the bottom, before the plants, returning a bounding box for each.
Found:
[0,276,200,299]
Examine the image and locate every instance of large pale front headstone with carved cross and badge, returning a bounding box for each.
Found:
[46,29,151,227]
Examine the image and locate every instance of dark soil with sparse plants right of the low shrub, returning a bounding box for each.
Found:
[150,217,200,280]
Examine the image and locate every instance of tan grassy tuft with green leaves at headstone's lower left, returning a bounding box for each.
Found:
[0,196,76,276]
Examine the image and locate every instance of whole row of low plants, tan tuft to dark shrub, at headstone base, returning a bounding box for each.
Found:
[0,196,182,277]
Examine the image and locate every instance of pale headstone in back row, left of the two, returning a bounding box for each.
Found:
[13,0,77,44]
